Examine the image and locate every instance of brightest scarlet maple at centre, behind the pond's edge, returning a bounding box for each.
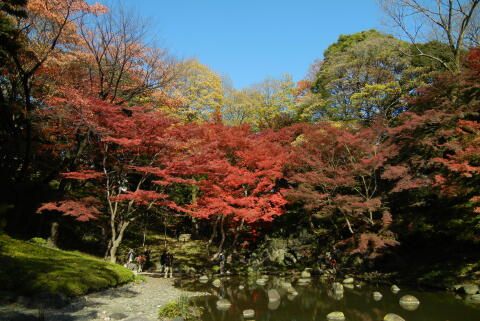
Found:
[176,123,286,252]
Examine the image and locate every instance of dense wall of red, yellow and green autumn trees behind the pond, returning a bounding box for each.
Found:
[0,0,480,279]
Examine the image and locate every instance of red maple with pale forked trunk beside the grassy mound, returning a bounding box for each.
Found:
[39,87,192,262]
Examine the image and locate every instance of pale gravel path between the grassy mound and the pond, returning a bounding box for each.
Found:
[0,274,206,321]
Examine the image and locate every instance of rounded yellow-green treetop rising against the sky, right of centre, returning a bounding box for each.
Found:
[303,30,426,123]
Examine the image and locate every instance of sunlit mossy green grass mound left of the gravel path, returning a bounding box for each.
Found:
[0,234,135,296]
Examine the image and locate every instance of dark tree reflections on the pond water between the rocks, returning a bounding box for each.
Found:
[188,278,480,321]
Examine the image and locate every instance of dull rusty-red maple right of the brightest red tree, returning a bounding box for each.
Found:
[286,123,396,257]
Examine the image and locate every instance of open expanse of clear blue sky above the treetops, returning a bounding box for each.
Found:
[119,0,380,88]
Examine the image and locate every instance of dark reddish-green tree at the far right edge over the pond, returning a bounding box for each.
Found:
[383,49,479,240]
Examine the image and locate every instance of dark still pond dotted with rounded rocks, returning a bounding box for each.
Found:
[178,276,480,321]
